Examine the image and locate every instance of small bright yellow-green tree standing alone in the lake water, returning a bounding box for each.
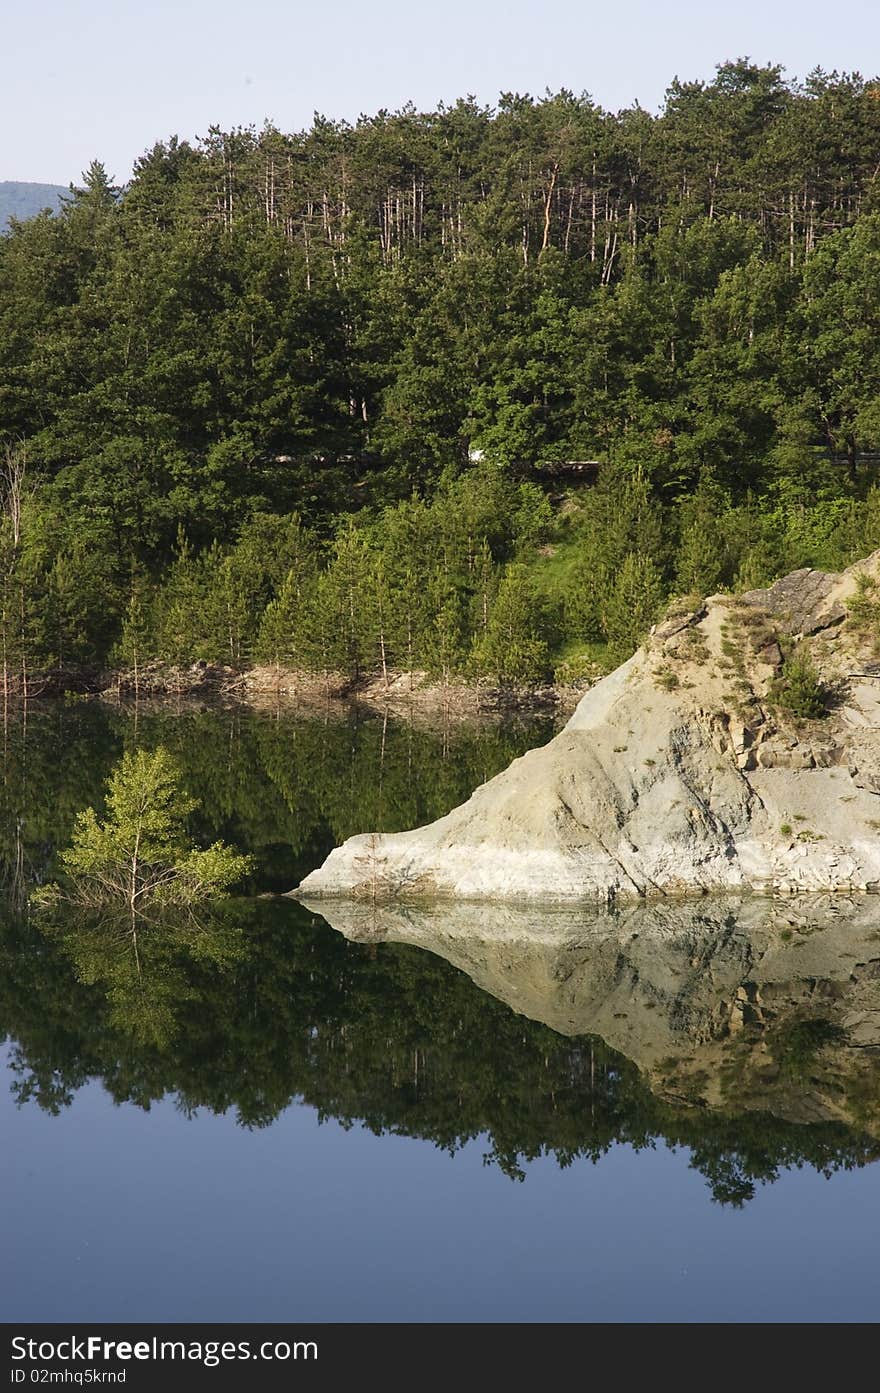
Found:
[47,745,252,915]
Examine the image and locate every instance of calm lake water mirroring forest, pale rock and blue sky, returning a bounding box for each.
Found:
[0,703,880,1321]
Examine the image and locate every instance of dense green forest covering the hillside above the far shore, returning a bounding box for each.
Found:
[0,60,880,690]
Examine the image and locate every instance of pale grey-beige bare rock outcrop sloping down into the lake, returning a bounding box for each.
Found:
[301,553,880,900]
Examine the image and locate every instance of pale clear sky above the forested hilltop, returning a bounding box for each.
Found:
[0,0,880,184]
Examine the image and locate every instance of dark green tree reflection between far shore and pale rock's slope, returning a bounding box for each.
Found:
[0,701,551,889]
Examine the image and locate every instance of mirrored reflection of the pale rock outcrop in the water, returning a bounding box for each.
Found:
[306,896,880,1134]
